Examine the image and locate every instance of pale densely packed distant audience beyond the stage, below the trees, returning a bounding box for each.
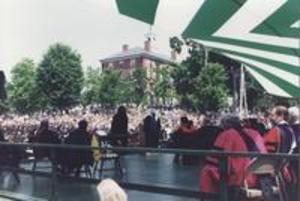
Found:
[0,106,201,143]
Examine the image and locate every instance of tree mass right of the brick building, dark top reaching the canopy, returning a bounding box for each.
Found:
[170,37,228,111]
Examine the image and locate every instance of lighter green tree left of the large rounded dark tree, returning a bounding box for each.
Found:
[7,59,44,113]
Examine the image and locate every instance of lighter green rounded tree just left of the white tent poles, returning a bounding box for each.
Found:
[191,63,228,111]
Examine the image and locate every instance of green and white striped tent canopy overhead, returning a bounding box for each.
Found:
[116,0,300,98]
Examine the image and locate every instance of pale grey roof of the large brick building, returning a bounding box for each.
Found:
[100,47,175,64]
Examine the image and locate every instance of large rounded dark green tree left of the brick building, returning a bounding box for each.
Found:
[37,43,83,109]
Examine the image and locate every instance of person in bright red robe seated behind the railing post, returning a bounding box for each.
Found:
[199,116,266,199]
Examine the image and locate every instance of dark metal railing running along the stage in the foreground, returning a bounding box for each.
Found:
[0,142,300,201]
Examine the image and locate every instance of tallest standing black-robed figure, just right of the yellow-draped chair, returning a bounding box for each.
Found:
[109,106,128,146]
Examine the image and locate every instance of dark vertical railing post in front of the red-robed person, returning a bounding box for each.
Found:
[219,156,229,201]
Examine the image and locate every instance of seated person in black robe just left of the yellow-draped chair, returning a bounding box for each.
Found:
[64,120,93,176]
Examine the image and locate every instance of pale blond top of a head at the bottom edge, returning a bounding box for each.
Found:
[97,179,127,201]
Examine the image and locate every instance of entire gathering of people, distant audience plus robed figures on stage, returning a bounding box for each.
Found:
[0,106,300,200]
